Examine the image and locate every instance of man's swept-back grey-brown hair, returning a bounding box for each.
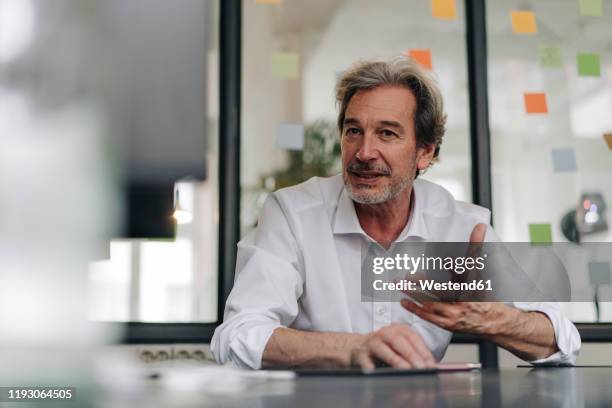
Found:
[336,56,446,175]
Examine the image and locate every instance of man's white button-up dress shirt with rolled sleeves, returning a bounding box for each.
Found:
[211,175,581,369]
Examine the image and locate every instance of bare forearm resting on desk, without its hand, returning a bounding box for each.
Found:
[261,327,366,367]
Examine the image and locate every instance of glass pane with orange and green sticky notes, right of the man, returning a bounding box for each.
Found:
[487,0,612,321]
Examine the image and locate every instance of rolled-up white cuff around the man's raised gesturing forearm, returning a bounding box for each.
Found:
[514,302,582,365]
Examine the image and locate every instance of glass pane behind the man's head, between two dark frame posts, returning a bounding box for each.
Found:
[241,0,472,234]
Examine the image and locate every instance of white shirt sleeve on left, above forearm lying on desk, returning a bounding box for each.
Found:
[211,194,304,369]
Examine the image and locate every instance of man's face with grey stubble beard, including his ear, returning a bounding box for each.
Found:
[341,86,434,204]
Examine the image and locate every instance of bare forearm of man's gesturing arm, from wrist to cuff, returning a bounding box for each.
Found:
[483,303,559,361]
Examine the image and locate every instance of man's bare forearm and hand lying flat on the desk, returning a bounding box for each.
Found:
[262,324,435,369]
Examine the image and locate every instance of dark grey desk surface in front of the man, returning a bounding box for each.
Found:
[147,368,612,408]
